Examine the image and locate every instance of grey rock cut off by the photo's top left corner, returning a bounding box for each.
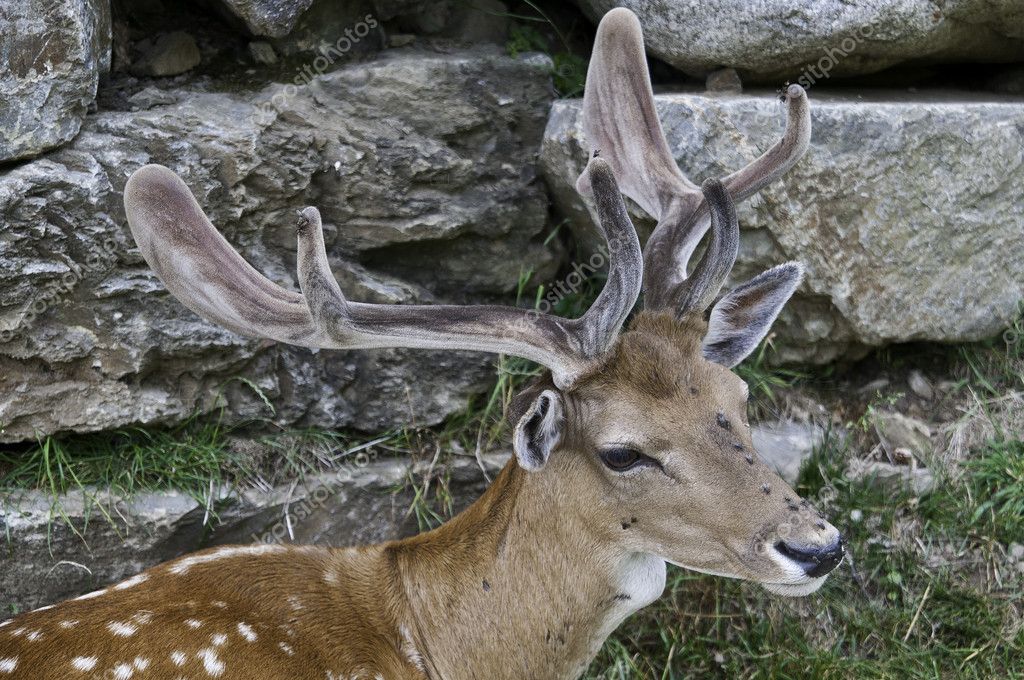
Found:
[0,0,111,162]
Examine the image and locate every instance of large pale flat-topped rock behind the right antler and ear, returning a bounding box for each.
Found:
[542,93,1024,363]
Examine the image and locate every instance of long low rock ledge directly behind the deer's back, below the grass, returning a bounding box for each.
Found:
[0,454,508,610]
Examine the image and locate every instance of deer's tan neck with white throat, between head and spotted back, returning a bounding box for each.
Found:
[394,460,665,680]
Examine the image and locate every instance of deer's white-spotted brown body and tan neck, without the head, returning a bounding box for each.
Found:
[0,454,665,680]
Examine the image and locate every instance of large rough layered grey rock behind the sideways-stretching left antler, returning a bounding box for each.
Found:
[0,49,559,441]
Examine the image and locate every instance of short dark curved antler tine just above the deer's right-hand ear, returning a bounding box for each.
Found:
[669,179,739,316]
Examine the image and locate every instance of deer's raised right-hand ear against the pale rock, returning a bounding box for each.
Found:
[703,262,804,369]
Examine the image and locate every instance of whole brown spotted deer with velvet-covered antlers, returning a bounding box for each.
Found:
[0,10,844,680]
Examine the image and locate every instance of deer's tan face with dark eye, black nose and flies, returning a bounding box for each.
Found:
[519,313,844,595]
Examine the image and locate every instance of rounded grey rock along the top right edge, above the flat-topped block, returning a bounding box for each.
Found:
[579,0,1024,81]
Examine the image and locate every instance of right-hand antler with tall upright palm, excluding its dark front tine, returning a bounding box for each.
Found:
[577,8,811,313]
